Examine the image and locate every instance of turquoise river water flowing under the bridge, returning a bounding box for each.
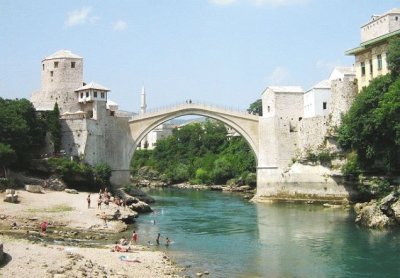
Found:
[135,189,400,277]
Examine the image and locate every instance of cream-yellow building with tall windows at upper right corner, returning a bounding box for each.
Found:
[346,8,400,91]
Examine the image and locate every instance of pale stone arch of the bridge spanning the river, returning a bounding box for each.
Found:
[128,103,259,165]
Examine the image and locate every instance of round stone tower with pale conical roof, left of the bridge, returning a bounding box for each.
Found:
[31,50,83,113]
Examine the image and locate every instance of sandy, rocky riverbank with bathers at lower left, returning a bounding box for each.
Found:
[0,190,184,278]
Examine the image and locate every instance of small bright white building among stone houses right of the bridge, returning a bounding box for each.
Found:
[304,80,331,118]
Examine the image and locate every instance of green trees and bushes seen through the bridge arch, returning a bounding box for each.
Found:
[131,120,256,184]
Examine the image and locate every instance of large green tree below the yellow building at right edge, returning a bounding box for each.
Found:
[338,75,400,173]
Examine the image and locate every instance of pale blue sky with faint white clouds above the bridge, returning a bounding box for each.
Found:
[0,0,400,112]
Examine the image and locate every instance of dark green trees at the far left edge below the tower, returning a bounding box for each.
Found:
[0,98,46,167]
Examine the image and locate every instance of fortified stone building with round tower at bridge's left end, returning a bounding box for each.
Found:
[31,50,133,184]
